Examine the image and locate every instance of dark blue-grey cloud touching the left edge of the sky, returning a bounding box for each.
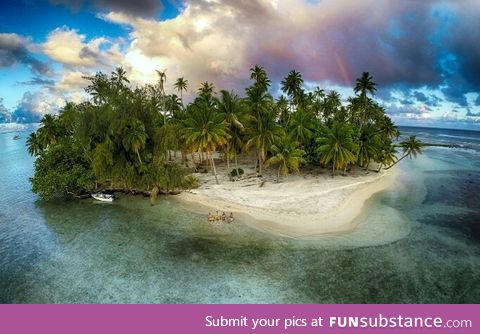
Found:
[0,33,53,76]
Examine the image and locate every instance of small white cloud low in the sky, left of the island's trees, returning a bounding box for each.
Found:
[11,89,65,123]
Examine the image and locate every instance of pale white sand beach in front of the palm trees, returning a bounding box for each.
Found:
[175,169,397,239]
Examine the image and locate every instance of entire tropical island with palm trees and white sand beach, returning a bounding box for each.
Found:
[27,65,424,238]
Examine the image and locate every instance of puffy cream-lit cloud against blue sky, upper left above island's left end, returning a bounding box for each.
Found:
[43,26,122,69]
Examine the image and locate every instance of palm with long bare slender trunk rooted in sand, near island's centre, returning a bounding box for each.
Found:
[185,101,229,184]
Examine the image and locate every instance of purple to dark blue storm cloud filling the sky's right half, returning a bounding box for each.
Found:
[238,0,480,111]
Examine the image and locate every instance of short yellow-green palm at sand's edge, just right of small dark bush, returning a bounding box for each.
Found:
[265,136,305,180]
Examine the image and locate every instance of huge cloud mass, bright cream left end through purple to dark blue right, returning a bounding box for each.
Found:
[97,0,480,106]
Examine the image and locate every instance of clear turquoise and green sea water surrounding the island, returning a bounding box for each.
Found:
[0,128,480,303]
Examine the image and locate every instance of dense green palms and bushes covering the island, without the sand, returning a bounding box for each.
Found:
[27,65,423,199]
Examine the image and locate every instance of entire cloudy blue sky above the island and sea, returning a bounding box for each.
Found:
[0,0,480,130]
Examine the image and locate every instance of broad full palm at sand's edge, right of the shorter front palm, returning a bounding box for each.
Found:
[318,122,357,176]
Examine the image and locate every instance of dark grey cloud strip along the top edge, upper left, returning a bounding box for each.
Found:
[50,0,163,17]
